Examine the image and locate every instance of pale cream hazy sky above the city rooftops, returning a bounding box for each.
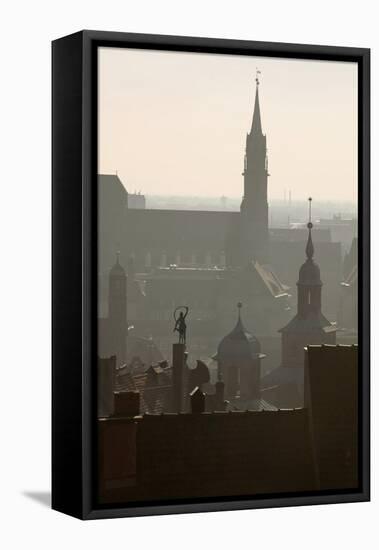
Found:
[99,48,357,201]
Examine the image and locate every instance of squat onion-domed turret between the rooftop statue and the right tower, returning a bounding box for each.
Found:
[216,302,265,399]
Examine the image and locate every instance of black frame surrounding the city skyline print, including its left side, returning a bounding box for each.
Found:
[52,31,370,519]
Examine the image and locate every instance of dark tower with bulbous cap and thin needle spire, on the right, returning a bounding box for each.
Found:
[279,197,337,368]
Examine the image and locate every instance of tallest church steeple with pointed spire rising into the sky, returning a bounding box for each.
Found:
[240,69,269,265]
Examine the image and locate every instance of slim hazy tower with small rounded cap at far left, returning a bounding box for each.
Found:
[108,252,128,366]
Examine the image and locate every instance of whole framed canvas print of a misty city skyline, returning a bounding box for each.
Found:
[52,31,370,519]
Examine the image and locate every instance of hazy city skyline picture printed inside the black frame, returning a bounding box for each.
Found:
[97,48,358,503]
